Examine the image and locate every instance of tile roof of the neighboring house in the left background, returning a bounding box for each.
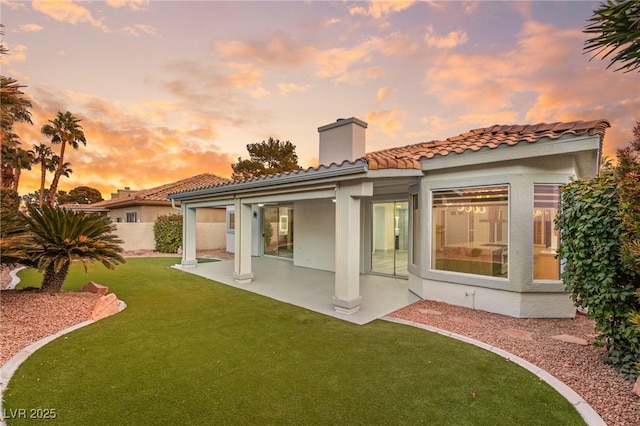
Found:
[93,173,231,207]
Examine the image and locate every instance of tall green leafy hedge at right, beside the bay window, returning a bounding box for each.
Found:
[556,164,640,380]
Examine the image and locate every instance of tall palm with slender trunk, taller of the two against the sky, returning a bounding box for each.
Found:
[41,111,87,206]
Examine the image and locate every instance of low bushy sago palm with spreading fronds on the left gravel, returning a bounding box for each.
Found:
[1,205,126,293]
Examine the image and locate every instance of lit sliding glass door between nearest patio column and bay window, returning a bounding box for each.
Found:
[371,201,409,276]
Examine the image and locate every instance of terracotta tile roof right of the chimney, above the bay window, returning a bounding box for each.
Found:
[363,120,611,170]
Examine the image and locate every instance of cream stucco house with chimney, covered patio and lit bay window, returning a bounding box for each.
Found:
[169,118,610,318]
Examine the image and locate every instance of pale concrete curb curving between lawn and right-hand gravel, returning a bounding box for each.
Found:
[381,316,607,426]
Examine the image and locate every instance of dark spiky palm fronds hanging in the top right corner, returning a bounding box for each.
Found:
[584,0,640,72]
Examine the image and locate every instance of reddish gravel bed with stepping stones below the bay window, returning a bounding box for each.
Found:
[390,300,640,426]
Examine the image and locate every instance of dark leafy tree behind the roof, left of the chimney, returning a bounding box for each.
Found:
[231,138,300,180]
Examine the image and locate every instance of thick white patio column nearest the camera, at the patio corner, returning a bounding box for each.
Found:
[333,182,373,314]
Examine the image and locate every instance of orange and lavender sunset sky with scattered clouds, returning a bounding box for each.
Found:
[0,0,640,199]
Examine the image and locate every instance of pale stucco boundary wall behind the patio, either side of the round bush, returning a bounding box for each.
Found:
[114,222,227,251]
